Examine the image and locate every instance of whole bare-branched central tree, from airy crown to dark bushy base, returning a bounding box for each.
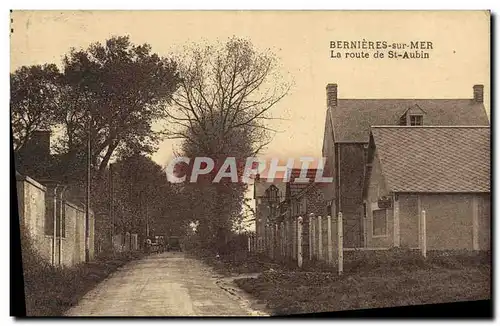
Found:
[168,37,290,246]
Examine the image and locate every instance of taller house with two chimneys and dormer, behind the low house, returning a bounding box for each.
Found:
[322,84,489,247]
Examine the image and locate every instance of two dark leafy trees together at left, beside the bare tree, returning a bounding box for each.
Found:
[11,37,180,180]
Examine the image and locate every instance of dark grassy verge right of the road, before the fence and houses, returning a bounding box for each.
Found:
[218,249,491,315]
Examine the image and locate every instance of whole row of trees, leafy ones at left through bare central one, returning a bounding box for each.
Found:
[11,37,290,246]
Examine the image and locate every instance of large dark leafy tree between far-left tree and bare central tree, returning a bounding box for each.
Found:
[62,36,179,174]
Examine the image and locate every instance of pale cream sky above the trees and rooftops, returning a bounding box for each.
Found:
[10,11,490,166]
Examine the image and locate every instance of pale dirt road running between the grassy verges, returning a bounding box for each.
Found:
[66,253,265,316]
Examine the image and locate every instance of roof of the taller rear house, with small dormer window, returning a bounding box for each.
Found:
[329,99,489,143]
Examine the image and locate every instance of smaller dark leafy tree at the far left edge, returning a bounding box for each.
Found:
[10,64,62,152]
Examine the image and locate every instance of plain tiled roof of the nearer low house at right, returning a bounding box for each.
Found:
[370,126,491,193]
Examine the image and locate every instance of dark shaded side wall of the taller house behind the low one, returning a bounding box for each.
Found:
[337,143,365,248]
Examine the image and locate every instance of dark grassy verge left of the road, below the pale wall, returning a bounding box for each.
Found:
[23,237,144,316]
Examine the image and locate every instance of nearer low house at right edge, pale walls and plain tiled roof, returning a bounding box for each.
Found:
[363,126,491,250]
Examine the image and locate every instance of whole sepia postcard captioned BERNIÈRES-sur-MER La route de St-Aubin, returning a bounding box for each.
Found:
[10,11,492,317]
